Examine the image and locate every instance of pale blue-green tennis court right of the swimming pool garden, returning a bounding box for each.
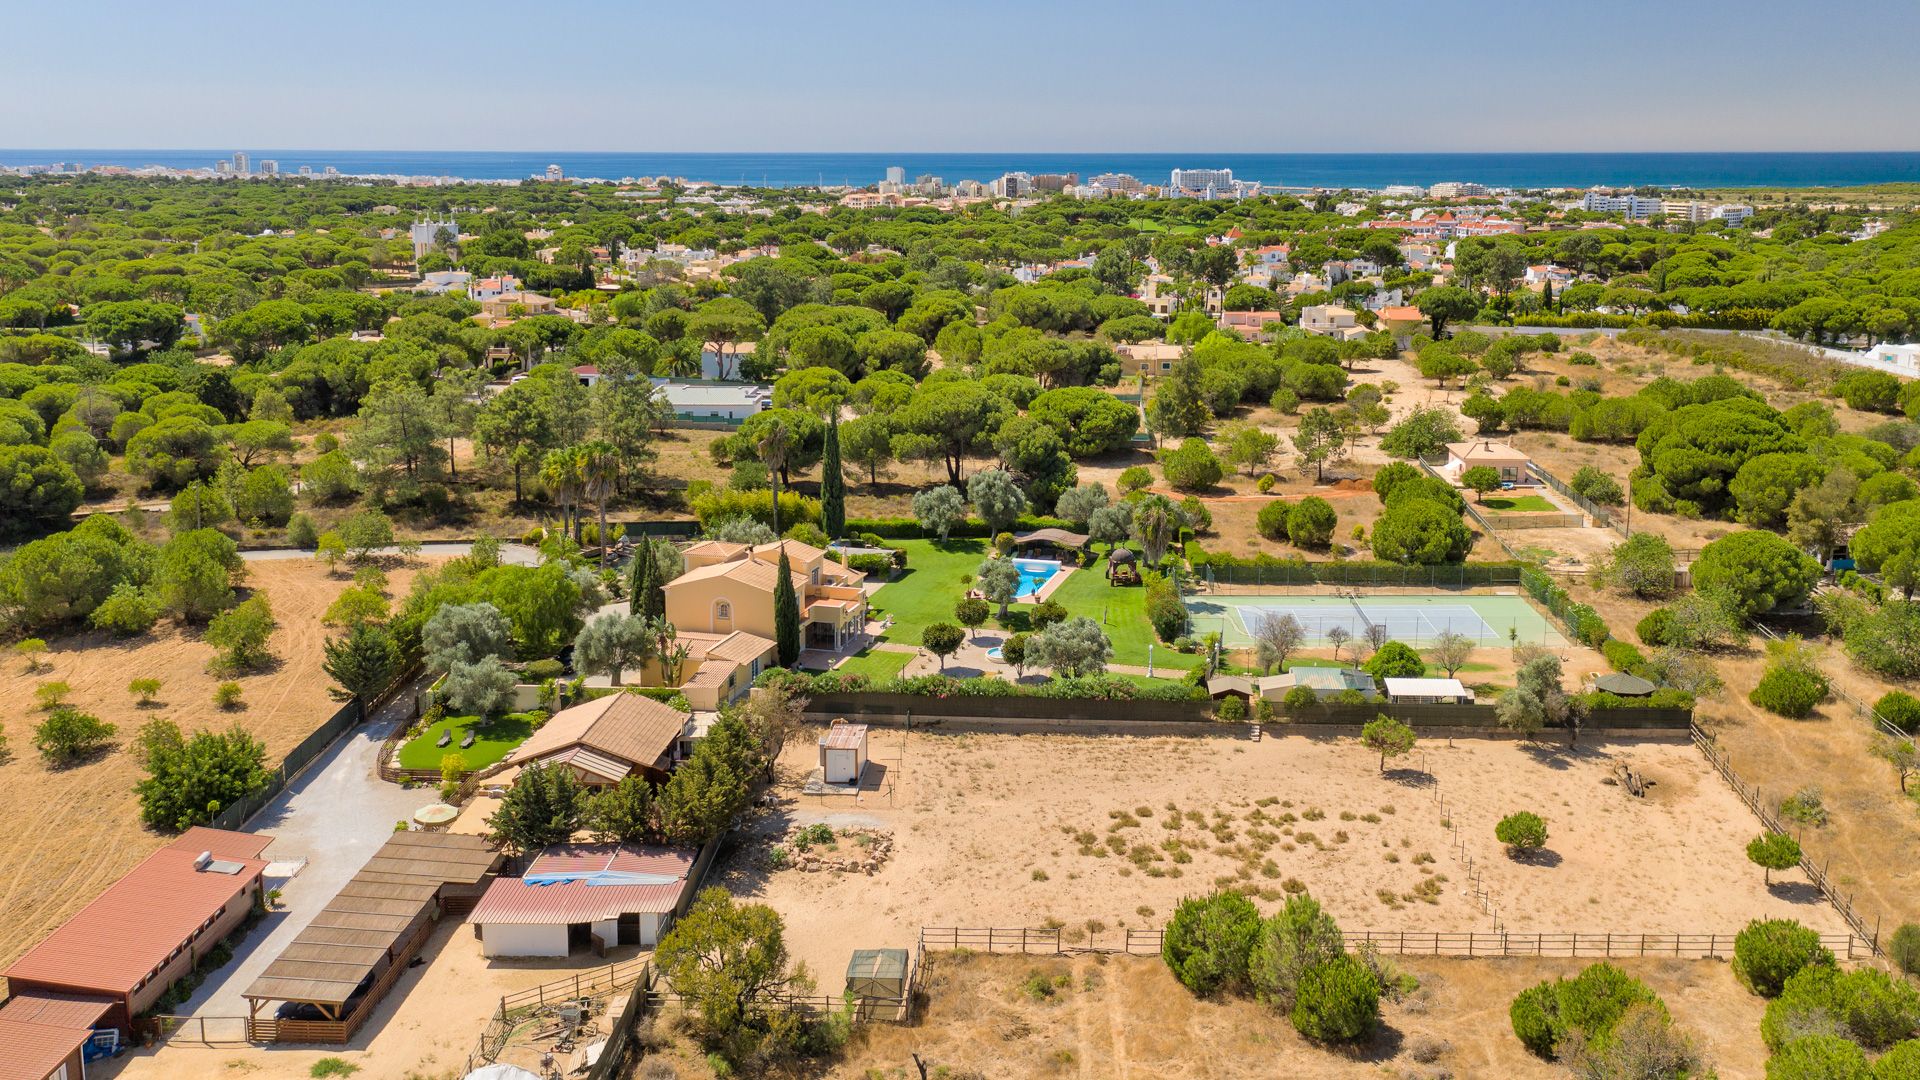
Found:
[1187,594,1567,648]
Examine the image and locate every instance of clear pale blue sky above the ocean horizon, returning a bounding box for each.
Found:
[0,0,1920,152]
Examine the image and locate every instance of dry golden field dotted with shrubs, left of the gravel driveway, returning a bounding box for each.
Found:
[0,559,432,967]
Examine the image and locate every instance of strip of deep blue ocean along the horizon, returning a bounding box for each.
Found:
[0,148,1920,188]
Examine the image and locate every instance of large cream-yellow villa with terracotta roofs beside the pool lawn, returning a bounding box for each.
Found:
[664,540,866,651]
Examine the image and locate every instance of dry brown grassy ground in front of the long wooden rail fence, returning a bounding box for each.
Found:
[641,953,1764,1080]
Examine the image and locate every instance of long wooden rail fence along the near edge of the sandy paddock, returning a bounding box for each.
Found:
[920,926,1874,959]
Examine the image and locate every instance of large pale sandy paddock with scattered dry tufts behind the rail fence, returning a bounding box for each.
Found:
[716,728,1843,992]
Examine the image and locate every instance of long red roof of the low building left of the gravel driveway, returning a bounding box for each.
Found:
[6,828,273,994]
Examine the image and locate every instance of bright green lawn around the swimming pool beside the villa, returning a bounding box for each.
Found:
[868,540,1200,671]
